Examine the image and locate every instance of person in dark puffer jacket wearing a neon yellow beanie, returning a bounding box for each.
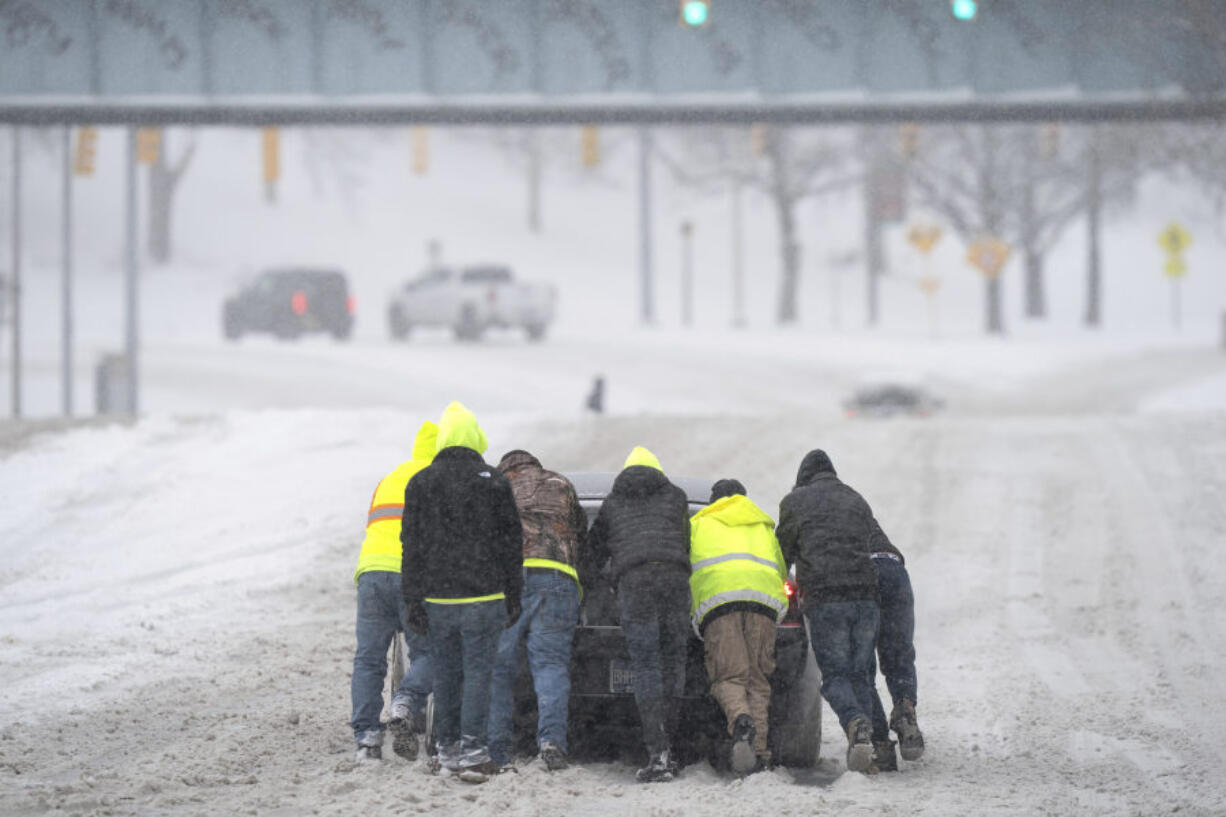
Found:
[585,447,690,783]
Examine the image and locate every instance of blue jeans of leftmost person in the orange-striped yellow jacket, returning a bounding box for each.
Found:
[349,570,433,745]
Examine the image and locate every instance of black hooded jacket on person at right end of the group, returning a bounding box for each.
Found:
[779,449,878,608]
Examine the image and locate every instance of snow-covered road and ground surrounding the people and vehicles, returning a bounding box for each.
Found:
[0,123,1226,817]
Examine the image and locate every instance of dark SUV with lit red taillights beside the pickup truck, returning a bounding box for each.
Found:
[222,267,353,340]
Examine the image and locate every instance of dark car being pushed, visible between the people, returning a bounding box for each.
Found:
[427,472,821,768]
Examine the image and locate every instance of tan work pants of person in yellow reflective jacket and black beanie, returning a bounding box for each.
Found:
[702,611,775,757]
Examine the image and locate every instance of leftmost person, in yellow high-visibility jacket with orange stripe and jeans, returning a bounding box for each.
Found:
[349,421,439,761]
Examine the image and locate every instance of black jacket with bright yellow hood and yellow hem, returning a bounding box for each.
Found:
[401,402,524,605]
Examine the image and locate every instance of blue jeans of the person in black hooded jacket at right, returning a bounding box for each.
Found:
[805,601,881,732]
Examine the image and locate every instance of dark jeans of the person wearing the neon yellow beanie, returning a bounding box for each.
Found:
[617,564,690,754]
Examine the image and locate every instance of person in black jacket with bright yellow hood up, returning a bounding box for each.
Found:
[400,402,524,781]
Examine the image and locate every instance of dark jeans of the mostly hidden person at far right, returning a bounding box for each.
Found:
[873,557,918,741]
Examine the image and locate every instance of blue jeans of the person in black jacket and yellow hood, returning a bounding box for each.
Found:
[425,599,506,767]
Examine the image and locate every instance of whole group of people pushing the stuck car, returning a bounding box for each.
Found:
[351,402,923,783]
